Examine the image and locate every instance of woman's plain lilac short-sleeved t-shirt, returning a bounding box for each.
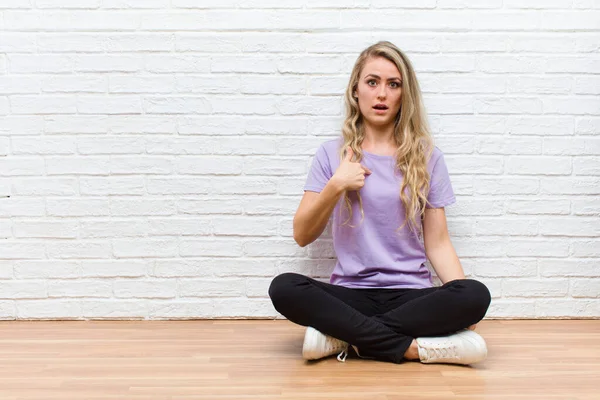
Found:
[304,139,456,289]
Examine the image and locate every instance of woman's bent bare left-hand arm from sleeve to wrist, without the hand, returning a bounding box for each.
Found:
[294,177,344,247]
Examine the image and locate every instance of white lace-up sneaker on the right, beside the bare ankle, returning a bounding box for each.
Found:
[416,330,487,364]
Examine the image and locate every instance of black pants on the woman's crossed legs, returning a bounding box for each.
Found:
[269,273,490,363]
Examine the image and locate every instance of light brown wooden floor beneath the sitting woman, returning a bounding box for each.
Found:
[0,320,600,400]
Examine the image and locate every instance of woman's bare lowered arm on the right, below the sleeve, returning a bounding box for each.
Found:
[423,208,465,284]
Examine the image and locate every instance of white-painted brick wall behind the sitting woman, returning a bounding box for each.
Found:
[0,0,600,319]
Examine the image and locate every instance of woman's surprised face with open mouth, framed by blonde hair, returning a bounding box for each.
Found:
[354,57,402,127]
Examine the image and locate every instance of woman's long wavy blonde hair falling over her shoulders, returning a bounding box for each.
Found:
[340,41,434,237]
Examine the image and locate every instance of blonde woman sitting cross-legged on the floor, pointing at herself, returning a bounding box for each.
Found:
[269,42,490,364]
